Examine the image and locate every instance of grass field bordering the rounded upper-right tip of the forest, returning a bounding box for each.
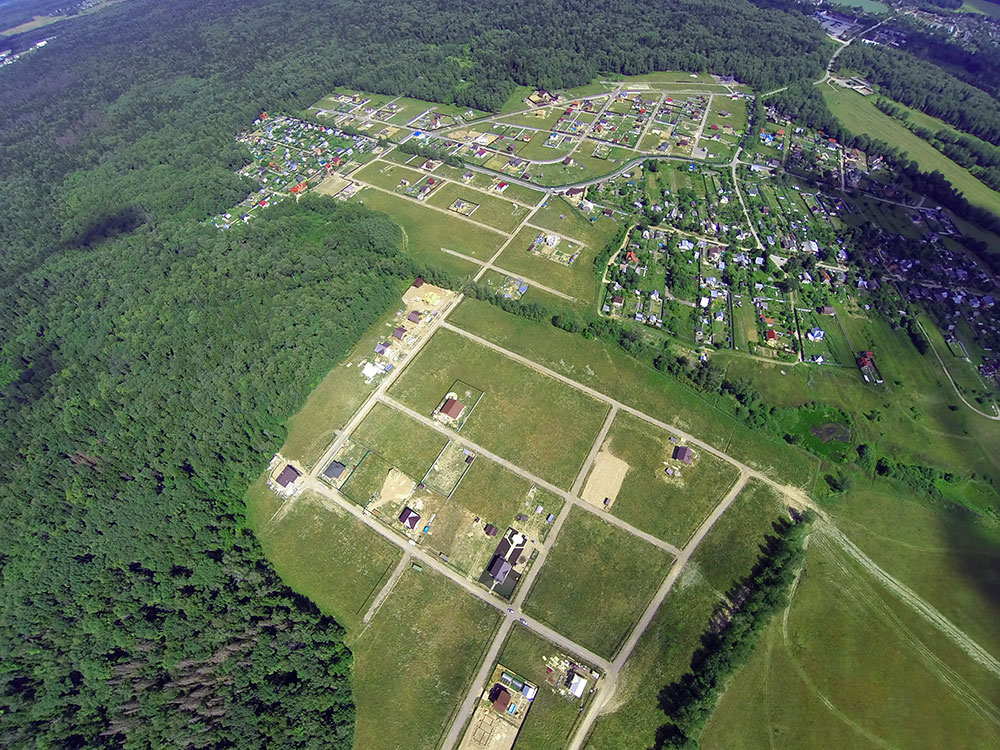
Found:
[361,190,506,268]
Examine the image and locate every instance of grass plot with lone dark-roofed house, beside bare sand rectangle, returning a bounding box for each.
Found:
[585,412,739,547]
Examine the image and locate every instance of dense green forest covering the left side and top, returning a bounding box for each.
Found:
[0,0,992,748]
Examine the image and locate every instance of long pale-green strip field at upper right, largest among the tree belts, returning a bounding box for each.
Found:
[820,85,1000,215]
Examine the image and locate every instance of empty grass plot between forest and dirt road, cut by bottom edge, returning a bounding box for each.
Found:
[351,569,499,750]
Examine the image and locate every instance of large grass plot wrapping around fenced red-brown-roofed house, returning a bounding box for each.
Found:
[390,330,607,487]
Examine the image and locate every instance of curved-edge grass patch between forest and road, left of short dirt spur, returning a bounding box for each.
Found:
[246,488,402,634]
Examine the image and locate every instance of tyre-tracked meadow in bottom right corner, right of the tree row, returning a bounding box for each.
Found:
[701,530,1000,748]
